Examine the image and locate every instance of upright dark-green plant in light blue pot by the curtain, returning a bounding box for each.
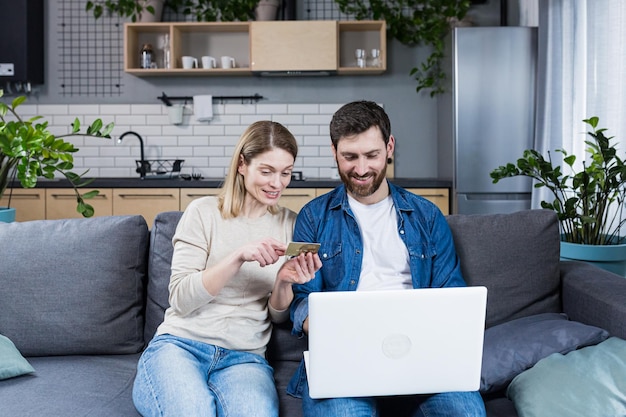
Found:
[490,117,626,275]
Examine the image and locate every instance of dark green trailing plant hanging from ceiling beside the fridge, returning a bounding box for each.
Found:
[335,0,471,97]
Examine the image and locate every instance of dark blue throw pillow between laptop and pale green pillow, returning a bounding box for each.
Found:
[480,313,609,393]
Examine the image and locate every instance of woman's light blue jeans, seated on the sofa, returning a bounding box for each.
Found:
[133,335,278,417]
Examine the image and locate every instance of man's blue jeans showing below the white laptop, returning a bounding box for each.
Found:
[302,376,486,417]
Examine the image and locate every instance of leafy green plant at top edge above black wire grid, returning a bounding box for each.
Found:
[85,0,168,22]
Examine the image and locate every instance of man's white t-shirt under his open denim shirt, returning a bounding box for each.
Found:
[348,196,413,291]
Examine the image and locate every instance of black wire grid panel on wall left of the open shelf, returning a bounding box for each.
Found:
[57,0,124,97]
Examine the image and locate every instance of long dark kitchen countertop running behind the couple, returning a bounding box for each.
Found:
[12,177,452,188]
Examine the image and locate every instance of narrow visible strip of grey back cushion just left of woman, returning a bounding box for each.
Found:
[145,211,183,342]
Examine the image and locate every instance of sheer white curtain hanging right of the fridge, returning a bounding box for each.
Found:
[532,0,626,208]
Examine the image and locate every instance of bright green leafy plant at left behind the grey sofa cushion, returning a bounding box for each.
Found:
[0,90,113,217]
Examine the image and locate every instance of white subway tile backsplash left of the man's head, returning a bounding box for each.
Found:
[29,102,342,178]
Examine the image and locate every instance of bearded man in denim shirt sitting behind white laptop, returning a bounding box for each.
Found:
[288,101,485,417]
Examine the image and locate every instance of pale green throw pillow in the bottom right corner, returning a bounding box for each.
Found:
[507,337,626,417]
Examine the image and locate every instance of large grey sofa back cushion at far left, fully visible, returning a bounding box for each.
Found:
[0,216,148,356]
